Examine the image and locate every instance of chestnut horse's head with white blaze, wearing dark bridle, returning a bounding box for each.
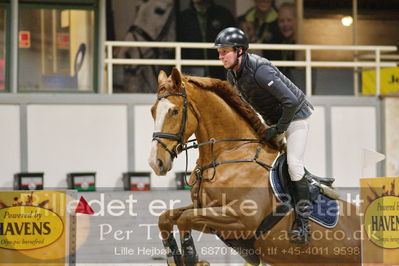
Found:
[148,68,198,175]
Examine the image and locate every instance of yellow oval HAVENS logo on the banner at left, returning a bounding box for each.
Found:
[0,206,64,250]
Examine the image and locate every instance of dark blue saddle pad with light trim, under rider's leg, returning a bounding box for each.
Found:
[270,154,339,228]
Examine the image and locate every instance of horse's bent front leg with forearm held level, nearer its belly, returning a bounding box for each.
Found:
[177,207,260,266]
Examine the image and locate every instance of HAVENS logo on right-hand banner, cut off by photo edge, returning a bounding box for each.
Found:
[364,183,399,249]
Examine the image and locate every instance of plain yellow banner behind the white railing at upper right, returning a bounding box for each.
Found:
[362,67,399,95]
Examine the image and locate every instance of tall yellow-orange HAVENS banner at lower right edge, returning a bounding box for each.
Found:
[360,177,399,265]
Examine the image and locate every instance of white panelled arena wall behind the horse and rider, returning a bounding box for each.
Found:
[0,95,390,189]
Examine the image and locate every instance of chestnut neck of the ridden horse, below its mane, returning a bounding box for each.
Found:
[191,91,257,161]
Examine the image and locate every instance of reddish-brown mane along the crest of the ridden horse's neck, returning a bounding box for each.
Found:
[184,76,267,137]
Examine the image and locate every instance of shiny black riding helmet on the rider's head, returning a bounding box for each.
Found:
[214,27,248,52]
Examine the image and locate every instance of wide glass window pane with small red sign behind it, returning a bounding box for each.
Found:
[18,7,94,91]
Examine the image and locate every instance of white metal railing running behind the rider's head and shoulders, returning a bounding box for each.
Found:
[105,41,397,96]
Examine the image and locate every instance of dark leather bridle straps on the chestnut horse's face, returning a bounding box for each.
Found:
[152,83,188,159]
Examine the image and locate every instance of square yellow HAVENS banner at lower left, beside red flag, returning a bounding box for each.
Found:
[0,190,74,265]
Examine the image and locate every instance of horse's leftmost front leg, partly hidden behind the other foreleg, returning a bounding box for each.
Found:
[158,205,194,265]
